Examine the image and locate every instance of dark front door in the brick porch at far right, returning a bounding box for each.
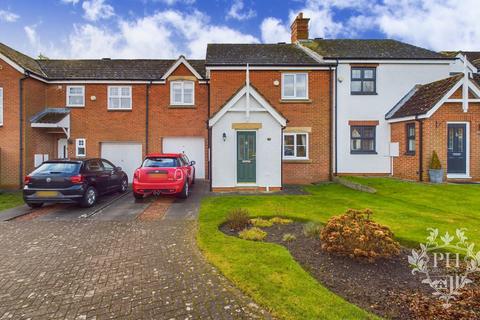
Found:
[447,124,467,174]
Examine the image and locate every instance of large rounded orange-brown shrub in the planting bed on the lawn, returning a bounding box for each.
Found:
[320,209,400,261]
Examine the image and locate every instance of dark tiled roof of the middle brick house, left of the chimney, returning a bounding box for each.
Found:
[206,43,318,66]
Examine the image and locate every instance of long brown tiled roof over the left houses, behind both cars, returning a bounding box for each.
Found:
[0,43,206,80]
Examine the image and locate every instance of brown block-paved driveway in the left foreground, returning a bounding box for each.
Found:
[0,184,270,320]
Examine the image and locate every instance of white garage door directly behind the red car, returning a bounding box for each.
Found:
[163,137,205,179]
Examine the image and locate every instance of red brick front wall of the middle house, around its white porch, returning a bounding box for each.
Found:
[210,70,331,184]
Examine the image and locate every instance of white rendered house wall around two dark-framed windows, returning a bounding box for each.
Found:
[337,63,450,174]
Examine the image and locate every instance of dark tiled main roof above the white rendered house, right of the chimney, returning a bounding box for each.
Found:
[301,39,451,59]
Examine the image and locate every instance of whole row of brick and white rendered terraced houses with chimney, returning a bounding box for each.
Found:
[0,14,480,191]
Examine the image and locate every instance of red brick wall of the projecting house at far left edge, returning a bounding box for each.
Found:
[0,60,22,188]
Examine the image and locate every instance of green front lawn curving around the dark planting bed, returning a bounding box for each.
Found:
[197,178,480,319]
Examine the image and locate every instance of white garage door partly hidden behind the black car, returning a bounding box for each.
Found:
[102,142,143,183]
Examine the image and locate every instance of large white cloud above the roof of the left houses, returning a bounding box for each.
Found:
[66,10,259,59]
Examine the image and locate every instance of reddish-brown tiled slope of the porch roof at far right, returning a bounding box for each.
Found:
[386,74,463,119]
